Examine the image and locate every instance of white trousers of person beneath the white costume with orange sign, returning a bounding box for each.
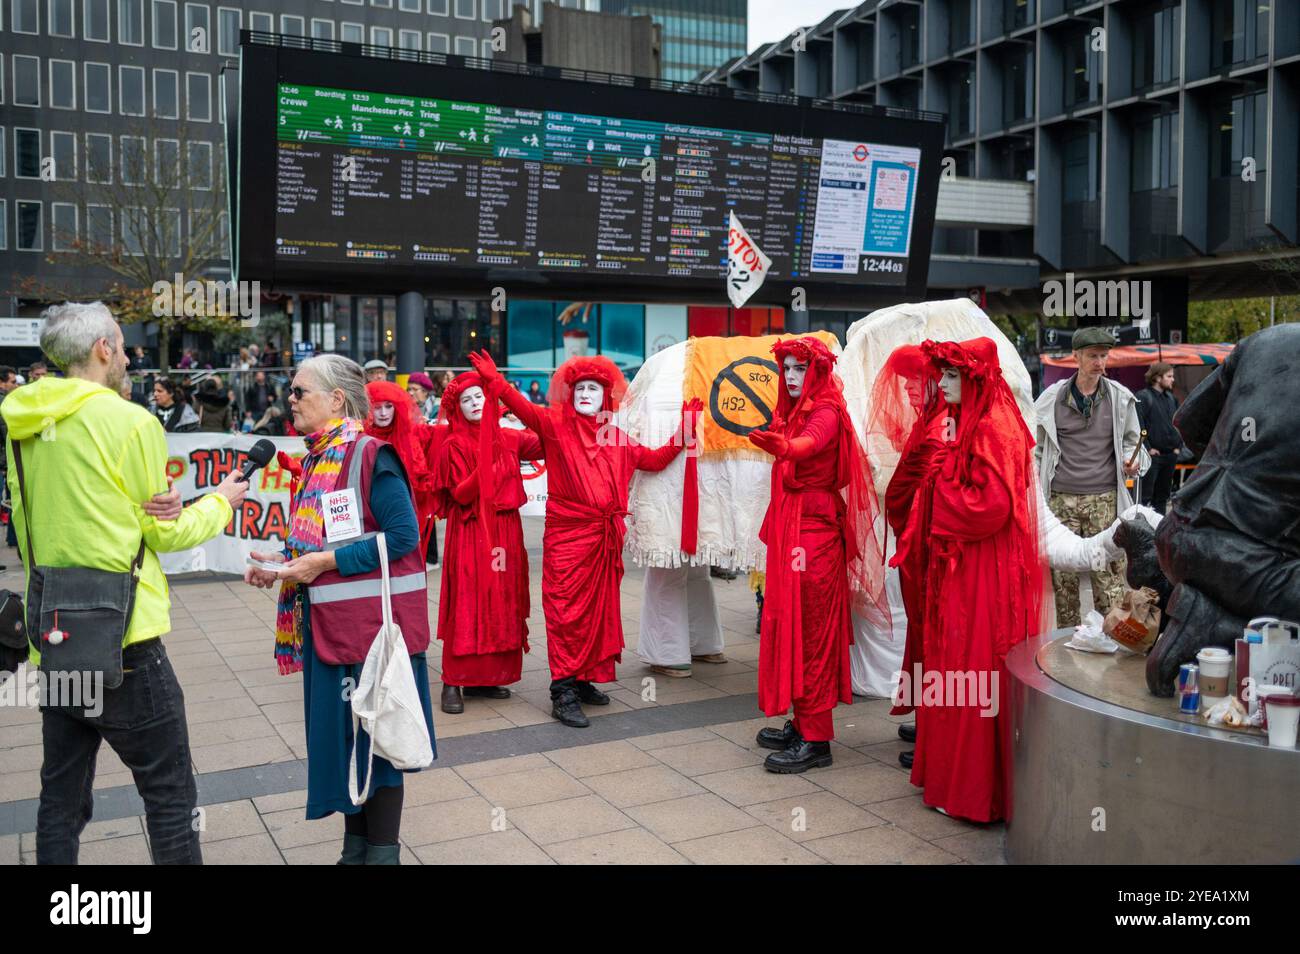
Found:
[637,567,723,665]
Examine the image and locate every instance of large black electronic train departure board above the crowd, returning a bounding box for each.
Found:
[239,45,943,307]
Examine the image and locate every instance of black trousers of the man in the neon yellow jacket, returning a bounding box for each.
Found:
[36,639,203,864]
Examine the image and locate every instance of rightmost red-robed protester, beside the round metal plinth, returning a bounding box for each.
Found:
[891,338,1045,821]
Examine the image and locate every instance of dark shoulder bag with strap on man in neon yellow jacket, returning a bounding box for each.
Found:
[12,441,144,689]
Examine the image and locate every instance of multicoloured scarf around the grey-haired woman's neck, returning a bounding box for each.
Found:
[276,417,361,676]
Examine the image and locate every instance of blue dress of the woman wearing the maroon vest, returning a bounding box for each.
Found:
[303,447,438,819]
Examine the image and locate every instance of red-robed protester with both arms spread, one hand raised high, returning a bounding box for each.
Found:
[469,352,702,728]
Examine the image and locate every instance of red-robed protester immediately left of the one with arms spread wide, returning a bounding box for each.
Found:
[433,372,542,715]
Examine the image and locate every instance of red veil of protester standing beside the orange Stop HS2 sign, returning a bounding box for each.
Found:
[768,337,889,629]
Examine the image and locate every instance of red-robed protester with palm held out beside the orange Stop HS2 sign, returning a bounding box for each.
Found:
[749,337,887,773]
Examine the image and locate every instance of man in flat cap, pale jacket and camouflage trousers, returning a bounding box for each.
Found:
[1034,328,1151,626]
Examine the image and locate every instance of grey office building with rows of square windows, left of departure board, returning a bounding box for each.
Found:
[0,0,530,357]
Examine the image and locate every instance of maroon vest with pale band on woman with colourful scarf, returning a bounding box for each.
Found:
[308,435,429,665]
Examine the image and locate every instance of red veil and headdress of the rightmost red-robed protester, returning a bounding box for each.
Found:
[920,338,1048,642]
